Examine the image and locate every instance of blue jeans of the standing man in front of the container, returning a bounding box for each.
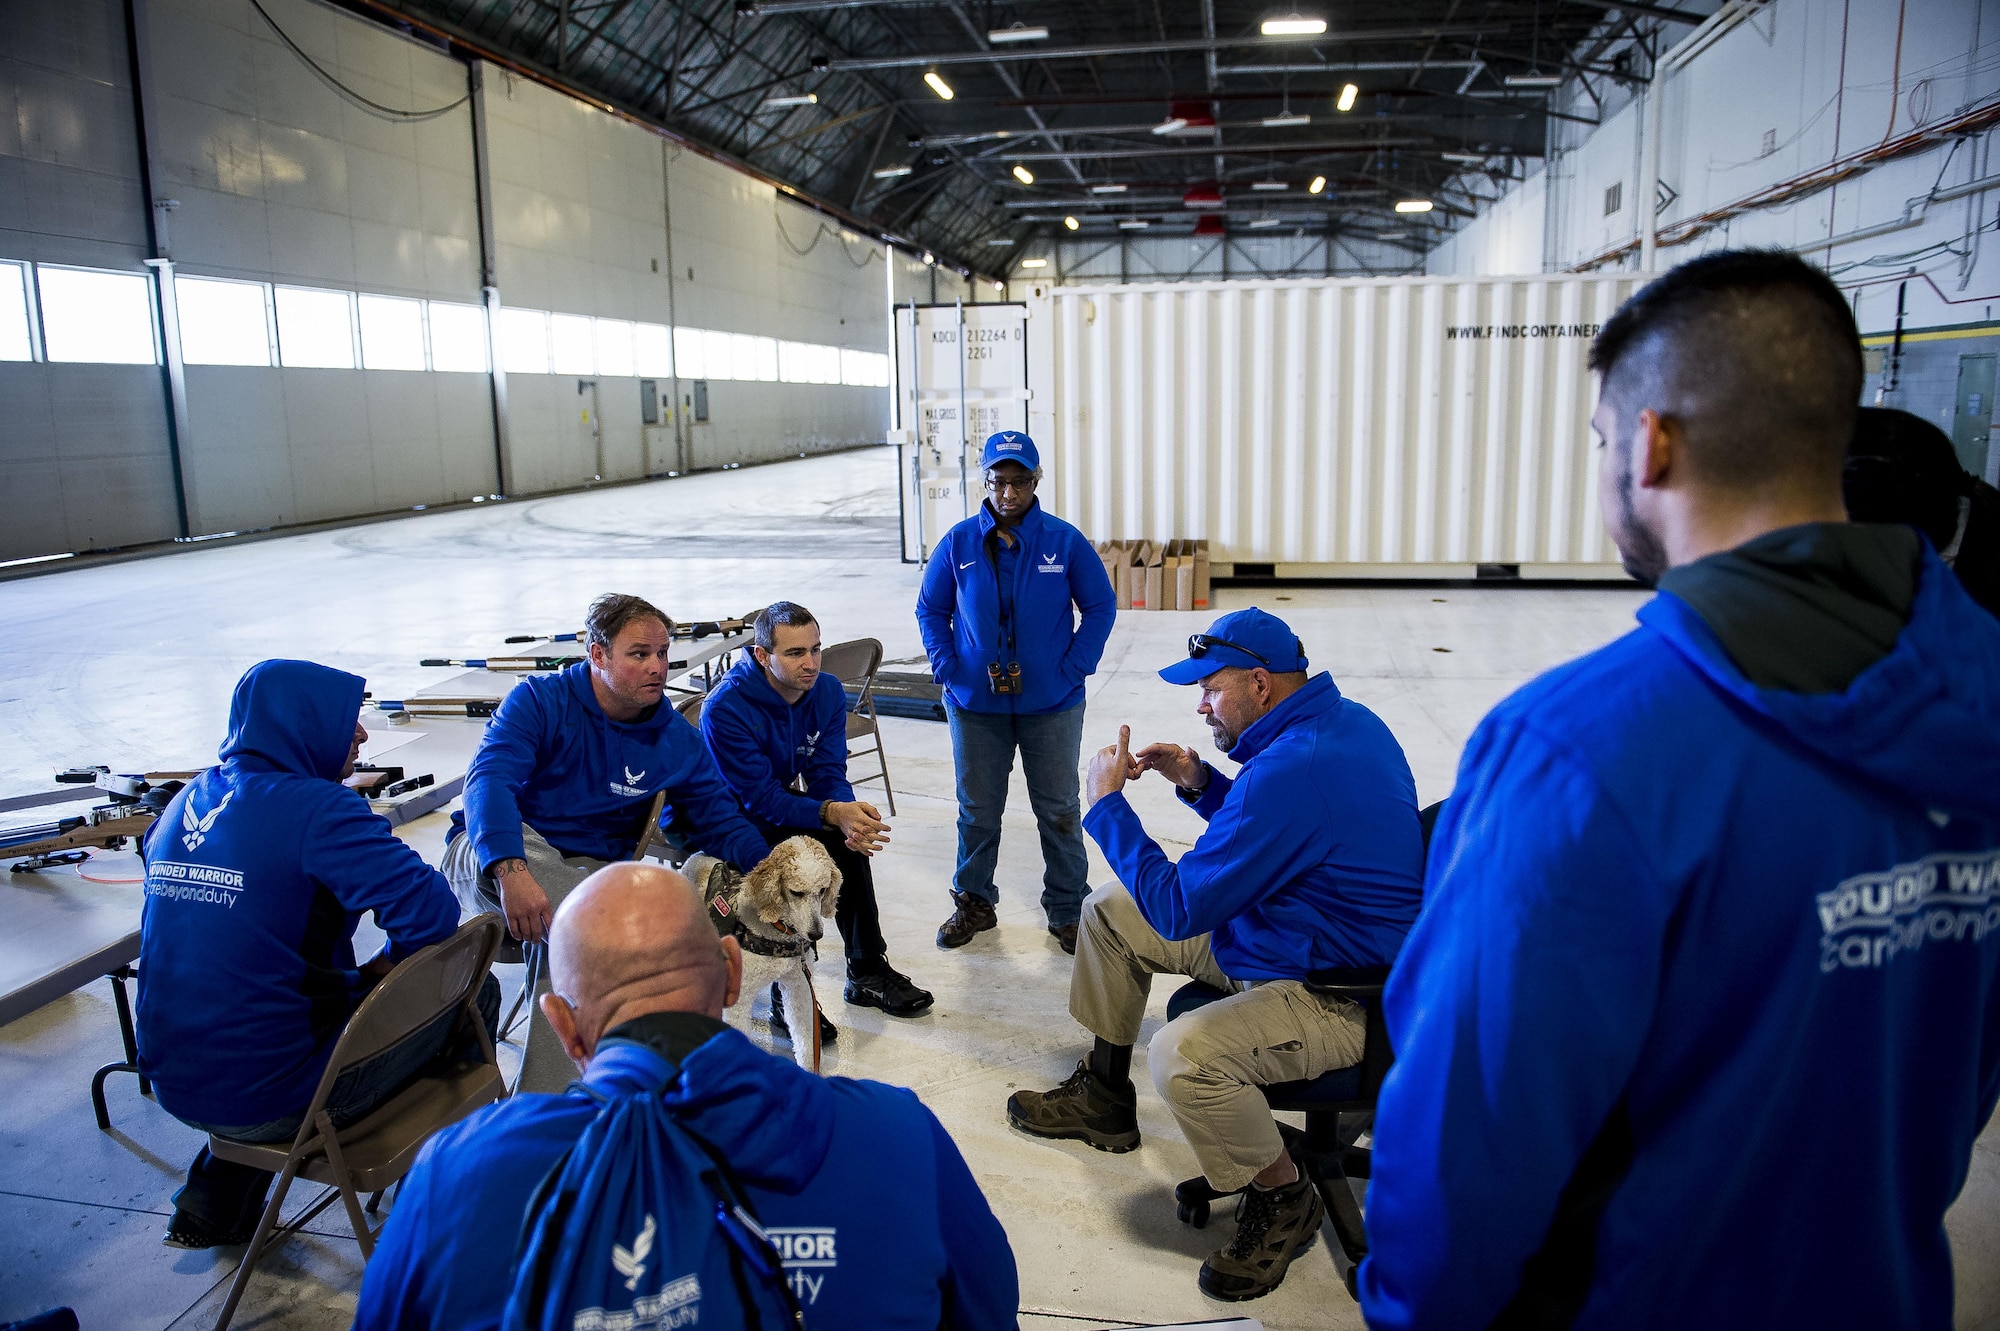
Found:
[944,701,1090,927]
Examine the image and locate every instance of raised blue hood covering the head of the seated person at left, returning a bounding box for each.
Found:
[220,662,368,781]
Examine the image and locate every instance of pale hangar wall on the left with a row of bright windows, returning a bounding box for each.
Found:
[0,0,944,560]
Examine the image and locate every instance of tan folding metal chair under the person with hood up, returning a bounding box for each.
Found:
[208,915,506,1331]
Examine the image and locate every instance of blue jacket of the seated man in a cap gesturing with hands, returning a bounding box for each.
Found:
[1084,671,1424,979]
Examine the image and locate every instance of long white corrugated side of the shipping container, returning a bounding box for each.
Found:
[1028,276,1638,576]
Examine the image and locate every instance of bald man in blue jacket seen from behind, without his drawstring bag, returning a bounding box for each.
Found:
[354,863,1020,1331]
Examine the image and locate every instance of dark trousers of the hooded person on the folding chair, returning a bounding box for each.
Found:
[174,975,500,1235]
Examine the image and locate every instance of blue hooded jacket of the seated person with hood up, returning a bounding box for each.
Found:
[138,662,458,1127]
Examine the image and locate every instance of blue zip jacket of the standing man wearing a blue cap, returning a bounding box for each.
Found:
[916,491,1118,715]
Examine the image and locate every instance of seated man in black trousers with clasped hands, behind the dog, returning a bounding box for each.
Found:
[702,602,932,1039]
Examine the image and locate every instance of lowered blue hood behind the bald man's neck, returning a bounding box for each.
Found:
[588,1027,834,1193]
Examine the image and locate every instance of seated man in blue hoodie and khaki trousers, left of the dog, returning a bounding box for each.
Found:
[442,594,770,1091]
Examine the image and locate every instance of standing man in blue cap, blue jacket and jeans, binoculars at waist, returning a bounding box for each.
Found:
[916,432,1118,953]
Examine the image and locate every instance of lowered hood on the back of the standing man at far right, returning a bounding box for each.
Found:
[1638,544,2000,817]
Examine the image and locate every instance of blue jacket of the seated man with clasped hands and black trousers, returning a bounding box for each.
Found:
[702,654,854,841]
